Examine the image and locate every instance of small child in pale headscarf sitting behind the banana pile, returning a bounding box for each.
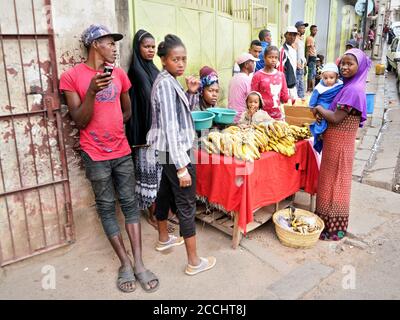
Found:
[238,91,272,125]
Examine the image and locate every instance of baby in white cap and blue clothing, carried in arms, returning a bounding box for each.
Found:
[310,63,343,153]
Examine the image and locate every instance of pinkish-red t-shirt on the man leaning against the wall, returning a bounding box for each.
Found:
[60,63,132,161]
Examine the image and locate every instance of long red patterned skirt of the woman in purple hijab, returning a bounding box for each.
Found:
[316,115,360,240]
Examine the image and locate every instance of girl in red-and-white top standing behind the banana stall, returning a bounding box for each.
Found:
[251,46,289,120]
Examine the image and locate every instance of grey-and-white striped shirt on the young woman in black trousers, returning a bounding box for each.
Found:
[147,70,199,169]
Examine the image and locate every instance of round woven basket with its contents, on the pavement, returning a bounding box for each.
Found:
[272,207,325,249]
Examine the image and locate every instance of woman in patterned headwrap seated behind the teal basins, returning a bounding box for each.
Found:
[196,67,220,111]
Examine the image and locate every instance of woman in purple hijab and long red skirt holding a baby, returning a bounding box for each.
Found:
[314,49,371,241]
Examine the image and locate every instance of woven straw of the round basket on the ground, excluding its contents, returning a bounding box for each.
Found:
[272,208,325,249]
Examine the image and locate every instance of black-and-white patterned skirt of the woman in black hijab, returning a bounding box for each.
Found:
[133,147,162,210]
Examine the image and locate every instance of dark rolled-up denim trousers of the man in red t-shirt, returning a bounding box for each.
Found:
[81,151,140,238]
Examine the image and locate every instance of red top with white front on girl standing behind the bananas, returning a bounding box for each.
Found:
[251,70,289,120]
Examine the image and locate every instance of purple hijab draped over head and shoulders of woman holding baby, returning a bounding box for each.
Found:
[329,49,372,127]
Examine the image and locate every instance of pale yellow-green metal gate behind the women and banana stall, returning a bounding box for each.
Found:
[131,0,279,105]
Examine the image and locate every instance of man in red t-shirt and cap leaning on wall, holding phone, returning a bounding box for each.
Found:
[60,25,159,292]
